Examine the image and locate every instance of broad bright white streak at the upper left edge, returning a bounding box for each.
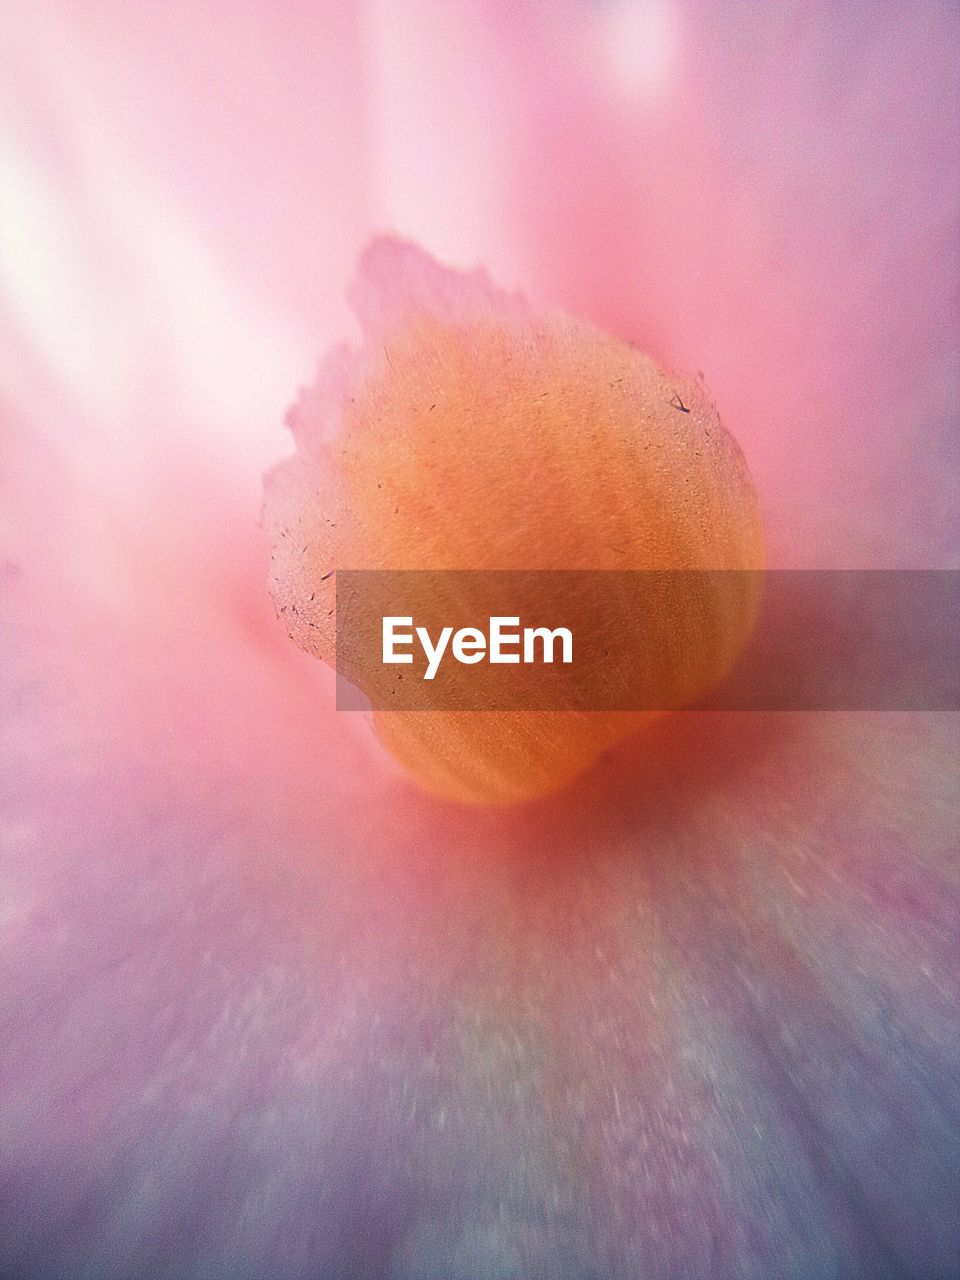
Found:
[0,6,311,468]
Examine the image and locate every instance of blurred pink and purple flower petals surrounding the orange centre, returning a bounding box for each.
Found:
[0,0,960,1280]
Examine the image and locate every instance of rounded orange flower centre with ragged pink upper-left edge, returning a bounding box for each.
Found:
[266,241,763,804]
